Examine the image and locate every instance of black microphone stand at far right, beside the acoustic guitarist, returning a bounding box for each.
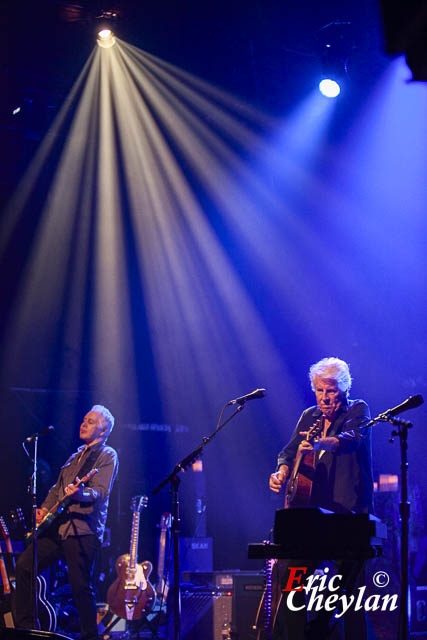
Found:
[361,412,413,640]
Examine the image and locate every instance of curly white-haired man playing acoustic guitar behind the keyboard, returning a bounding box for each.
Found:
[269,358,373,640]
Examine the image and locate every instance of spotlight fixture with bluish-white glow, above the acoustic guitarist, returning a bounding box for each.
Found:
[317,22,354,98]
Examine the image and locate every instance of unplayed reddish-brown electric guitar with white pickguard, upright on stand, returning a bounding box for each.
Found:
[107,496,156,620]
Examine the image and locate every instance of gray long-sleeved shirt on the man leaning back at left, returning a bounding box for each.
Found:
[42,442,119,542]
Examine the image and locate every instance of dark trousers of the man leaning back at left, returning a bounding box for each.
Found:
[15,535,99,640]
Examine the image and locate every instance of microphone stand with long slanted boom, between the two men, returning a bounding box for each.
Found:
[152,401,245,640]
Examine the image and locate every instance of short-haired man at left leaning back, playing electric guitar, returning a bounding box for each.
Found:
[15,405,118,640]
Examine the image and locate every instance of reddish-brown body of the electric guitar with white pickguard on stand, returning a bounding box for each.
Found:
[107,553,155,620]
